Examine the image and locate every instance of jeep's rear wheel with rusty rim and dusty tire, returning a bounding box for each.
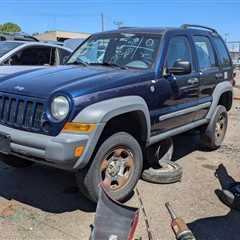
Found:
[201,105,228,150]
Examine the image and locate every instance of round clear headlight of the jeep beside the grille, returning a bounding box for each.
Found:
[51,96,69,121]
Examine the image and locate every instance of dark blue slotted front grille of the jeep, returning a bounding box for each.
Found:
[0,96,44,130]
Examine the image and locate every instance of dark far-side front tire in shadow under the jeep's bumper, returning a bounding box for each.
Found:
[0,154,34,168]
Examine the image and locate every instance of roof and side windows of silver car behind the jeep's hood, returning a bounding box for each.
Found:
[0,41,72,66]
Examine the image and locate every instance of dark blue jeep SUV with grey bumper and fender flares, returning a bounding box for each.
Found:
[0,25,233,201]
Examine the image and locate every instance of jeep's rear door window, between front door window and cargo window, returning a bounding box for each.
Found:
[193,36,216,71]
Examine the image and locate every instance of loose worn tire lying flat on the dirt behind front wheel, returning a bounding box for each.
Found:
[142,161,183,184]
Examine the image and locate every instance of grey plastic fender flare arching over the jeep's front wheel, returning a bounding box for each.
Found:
[73,96,151,169]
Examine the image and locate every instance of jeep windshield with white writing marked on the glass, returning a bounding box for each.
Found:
[68,33,161,69]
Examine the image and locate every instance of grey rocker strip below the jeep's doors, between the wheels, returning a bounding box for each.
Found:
[148,119,209,146]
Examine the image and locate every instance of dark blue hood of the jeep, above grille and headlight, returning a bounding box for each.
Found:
[0,65,150,98]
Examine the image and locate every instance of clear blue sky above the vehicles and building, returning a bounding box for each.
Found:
[0,0,240,40]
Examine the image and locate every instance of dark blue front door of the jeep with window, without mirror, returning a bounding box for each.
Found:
[152,35,199,135]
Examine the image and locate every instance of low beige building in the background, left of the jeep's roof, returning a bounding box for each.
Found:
[34,31,90,42]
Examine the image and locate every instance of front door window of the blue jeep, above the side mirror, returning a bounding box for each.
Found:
[166,36,192,68]
